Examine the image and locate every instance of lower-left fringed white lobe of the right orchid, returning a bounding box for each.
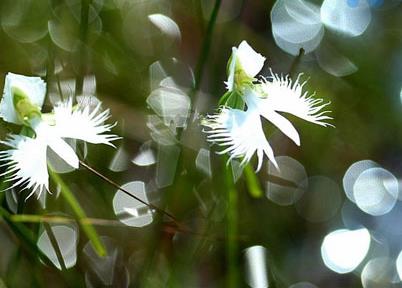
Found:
[203,108,277,171]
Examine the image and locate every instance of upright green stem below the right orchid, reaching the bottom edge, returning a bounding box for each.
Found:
[225,164,239,288]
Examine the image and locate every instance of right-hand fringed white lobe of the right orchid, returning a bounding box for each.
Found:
[258,71,332,126]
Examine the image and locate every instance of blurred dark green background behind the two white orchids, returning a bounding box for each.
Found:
[0,0,402,288]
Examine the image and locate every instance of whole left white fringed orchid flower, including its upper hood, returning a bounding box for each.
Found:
[0,75,119,197]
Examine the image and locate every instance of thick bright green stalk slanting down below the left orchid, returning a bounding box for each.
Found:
[49,169,106,256]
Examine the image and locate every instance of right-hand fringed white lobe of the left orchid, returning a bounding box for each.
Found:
[54,99,120,147]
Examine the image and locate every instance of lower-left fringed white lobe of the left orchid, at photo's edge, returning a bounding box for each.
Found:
[0,134,49,197]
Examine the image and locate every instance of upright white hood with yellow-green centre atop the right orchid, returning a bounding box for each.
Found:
[225,41,265,91]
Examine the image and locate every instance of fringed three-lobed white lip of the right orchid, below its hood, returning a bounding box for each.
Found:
[202,74,332,171]
